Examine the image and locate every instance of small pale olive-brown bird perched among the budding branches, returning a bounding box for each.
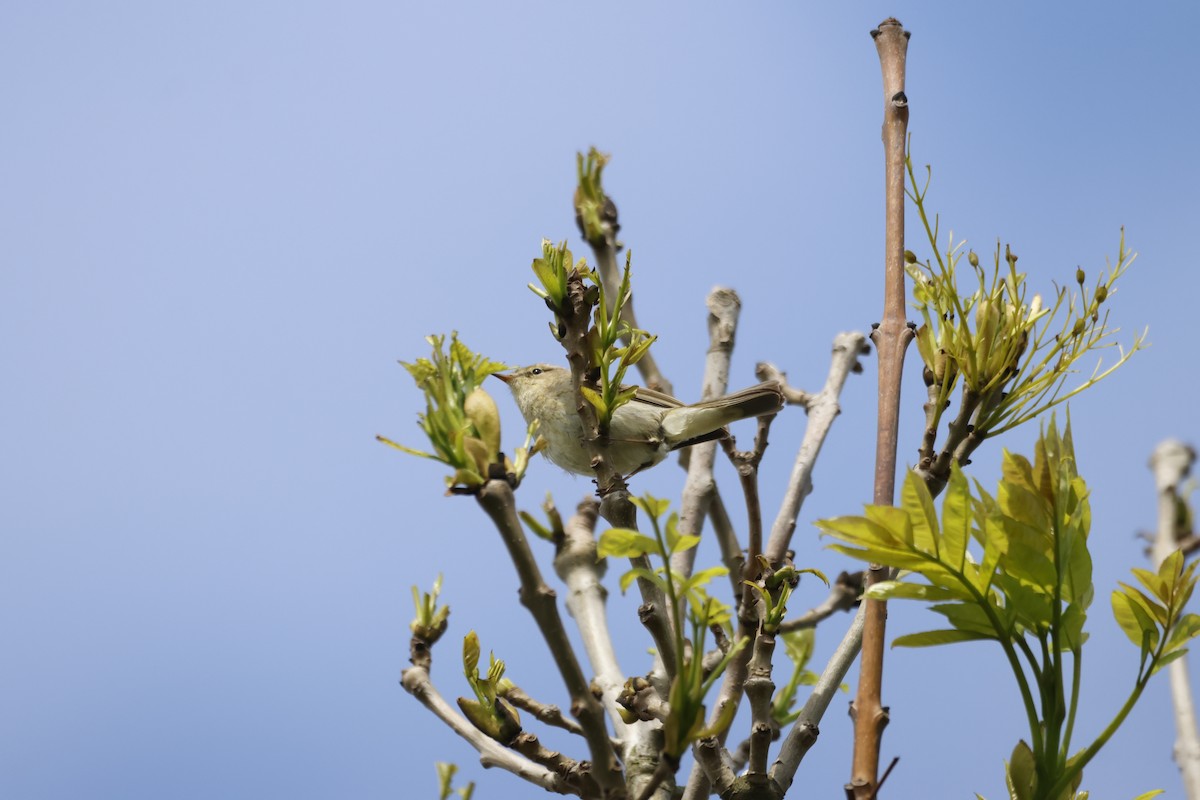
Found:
[496,363,784,477]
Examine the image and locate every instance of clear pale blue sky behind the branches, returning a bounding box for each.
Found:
[0,1,1200,800]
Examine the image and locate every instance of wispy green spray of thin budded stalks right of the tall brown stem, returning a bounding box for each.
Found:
[905,149,1146,493]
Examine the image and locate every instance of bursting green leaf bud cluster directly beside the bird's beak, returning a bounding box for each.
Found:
[376,333,540,492]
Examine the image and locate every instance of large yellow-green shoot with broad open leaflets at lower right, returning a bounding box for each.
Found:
[817,420,1200,800]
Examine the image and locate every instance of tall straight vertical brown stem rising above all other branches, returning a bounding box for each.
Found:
[846,18,913,800]
